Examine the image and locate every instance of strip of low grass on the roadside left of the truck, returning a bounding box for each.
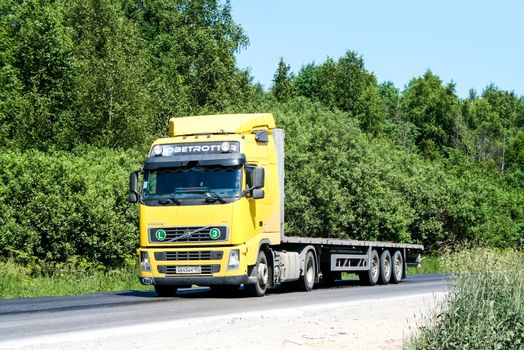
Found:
[0,261,150,299]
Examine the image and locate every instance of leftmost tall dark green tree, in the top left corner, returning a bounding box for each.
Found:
[0,0,74,149]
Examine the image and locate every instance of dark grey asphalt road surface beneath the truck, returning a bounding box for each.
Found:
[0,274,447,348]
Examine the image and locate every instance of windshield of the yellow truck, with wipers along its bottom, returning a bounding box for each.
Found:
[142,166,242,202]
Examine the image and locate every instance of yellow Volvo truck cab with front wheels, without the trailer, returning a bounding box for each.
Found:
[129,113,283,295]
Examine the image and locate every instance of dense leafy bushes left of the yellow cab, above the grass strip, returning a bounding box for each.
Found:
[0,148,141,269]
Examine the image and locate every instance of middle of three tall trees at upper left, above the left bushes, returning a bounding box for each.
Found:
[63,0,152,147]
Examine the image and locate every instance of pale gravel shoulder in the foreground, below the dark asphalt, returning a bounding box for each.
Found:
[0,293,444,350]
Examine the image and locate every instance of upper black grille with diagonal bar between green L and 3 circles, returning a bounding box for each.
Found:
[149,226,228,243]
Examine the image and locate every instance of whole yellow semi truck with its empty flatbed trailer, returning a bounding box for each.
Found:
[129,113,423,296]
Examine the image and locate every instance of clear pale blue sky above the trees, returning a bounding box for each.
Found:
[231,0,524,97]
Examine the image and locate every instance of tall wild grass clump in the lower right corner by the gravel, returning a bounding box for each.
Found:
[405,248,524,350]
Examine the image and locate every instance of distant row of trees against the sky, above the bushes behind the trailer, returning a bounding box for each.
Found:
[271,51,524,173]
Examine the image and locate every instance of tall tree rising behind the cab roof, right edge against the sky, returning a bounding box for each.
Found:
[126,0,254,133]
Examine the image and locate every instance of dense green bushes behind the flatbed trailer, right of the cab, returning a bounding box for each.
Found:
[268,98,524,249]
